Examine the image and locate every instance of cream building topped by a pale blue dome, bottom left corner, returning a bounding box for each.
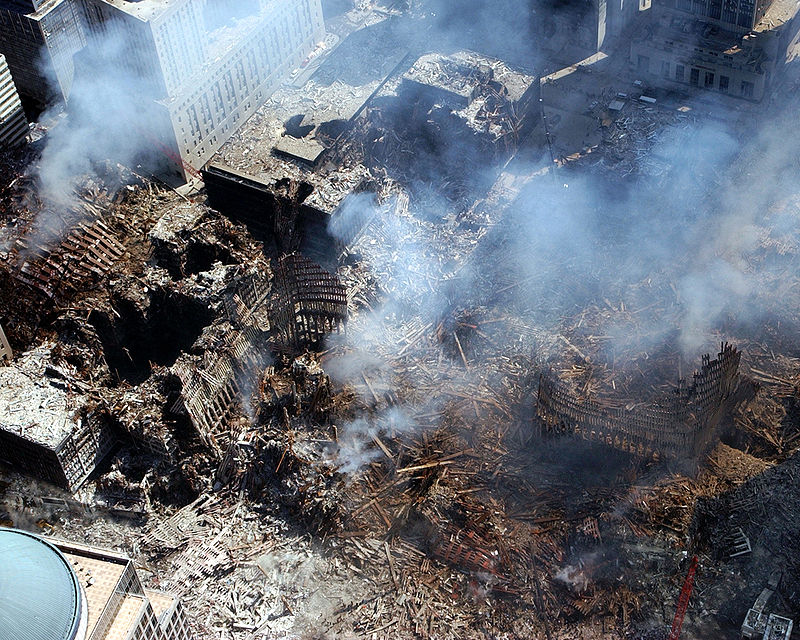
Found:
[0,528,192,640]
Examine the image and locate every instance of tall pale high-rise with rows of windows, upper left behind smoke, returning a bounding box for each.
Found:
[80,0,324,180]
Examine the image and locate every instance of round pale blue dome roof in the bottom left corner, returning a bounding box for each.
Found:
[0,528,82,640]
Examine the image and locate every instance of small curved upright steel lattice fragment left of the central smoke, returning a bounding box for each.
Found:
[272,254,347,350]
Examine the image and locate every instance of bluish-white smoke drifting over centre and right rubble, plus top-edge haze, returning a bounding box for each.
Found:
[314,2,800,476]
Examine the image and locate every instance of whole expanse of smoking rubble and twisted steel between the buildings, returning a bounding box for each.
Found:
[0,3,800,639]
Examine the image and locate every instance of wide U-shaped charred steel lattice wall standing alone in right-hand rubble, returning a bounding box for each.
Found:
[537,343,741,458]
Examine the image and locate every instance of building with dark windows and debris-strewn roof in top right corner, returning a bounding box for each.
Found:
[630,0,800,101]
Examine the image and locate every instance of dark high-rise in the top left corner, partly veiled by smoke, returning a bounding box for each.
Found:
[0,0,86,105]
